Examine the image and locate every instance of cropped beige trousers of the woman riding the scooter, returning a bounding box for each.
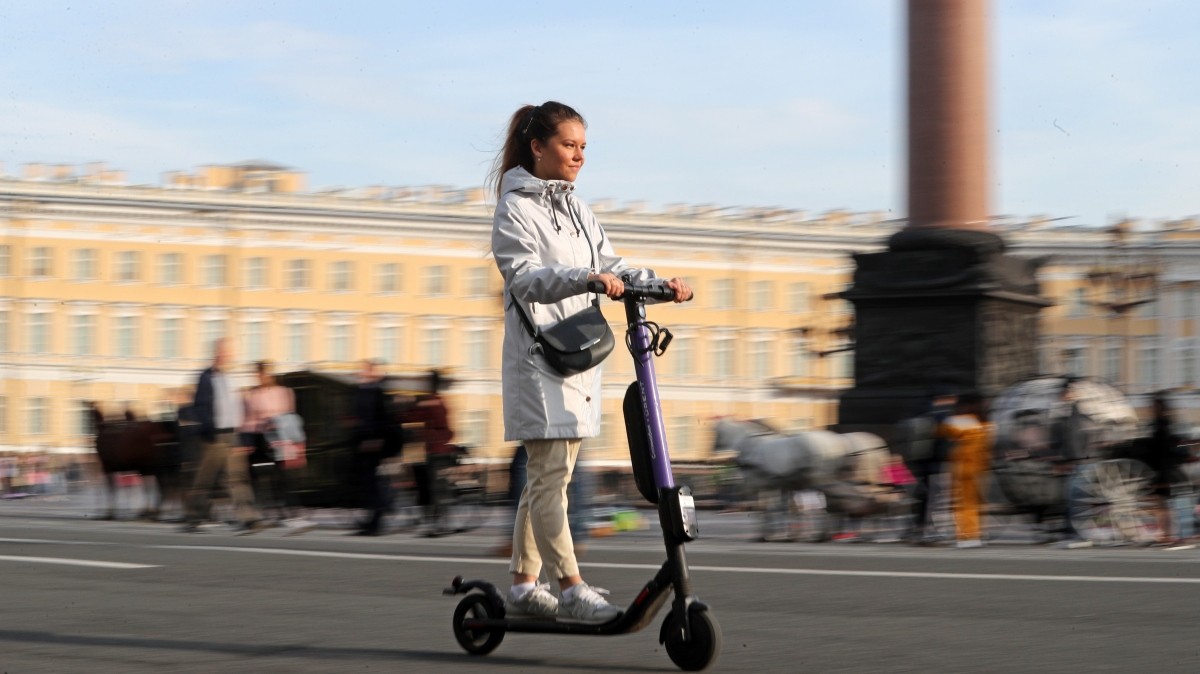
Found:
[509,439,582,580]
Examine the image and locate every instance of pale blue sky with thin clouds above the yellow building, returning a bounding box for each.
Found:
[0,0,1200,224]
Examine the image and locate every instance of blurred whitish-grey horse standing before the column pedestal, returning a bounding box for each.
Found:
[714,419,898,540]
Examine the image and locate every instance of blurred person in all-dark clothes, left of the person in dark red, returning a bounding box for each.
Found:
[350,360,390,536]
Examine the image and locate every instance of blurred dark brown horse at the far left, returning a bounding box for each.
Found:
[92,413,181,519]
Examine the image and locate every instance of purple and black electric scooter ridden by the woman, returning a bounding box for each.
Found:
[443,281,721,672]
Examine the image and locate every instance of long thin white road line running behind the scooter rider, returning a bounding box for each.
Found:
[151,546,1200,585]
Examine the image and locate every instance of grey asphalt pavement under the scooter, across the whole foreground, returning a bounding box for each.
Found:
[0,486,1200,674]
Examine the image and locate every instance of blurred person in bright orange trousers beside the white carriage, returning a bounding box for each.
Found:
[937,393,994,548]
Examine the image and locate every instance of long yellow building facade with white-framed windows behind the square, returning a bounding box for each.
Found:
[0,162,1200,461]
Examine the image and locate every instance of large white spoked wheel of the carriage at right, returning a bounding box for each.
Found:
[1068,458,1157,544]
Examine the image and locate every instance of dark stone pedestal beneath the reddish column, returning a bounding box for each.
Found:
[838,228,1051,438]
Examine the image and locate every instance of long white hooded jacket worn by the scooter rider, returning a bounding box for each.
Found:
[492,167,654,441]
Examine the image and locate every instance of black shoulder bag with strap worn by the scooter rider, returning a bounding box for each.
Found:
[512,214,616,377]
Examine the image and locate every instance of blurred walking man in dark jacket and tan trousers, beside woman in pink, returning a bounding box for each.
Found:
[184,338,264,534]
